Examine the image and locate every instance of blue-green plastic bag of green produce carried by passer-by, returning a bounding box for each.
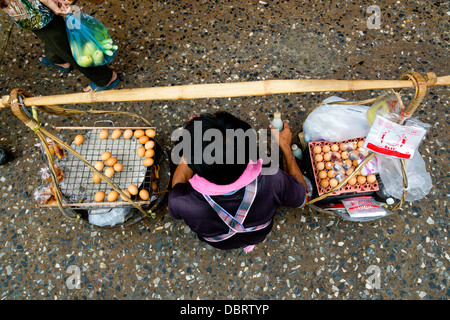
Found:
[65,12,118,67]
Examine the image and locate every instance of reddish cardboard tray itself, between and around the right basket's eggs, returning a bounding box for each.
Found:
[308,138,379,196]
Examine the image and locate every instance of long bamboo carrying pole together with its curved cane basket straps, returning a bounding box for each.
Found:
[0,71,450,220]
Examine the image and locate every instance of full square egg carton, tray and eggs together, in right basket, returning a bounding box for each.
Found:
[308,137,379,196]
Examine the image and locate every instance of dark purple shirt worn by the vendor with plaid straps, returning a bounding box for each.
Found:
[169,170,306,250]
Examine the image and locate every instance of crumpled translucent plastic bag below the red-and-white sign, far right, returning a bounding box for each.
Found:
[377,151,433,202]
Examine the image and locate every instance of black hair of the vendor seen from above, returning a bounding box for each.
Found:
[179,111,257,185]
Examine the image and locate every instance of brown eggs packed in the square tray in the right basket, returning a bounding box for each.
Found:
[310,139,377,194]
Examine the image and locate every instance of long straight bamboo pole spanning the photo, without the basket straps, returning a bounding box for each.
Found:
[2,73,450,106]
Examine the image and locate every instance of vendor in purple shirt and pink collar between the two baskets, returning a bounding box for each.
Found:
[169,111,306,252]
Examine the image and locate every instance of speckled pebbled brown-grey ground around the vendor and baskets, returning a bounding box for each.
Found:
[0,0,450,300]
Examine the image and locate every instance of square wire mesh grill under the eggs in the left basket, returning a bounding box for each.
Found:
[60,127,150,206]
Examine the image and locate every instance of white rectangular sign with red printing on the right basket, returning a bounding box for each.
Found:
[363,115,427,159]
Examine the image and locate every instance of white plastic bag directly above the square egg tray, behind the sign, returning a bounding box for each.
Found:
[303,96,369,143]
